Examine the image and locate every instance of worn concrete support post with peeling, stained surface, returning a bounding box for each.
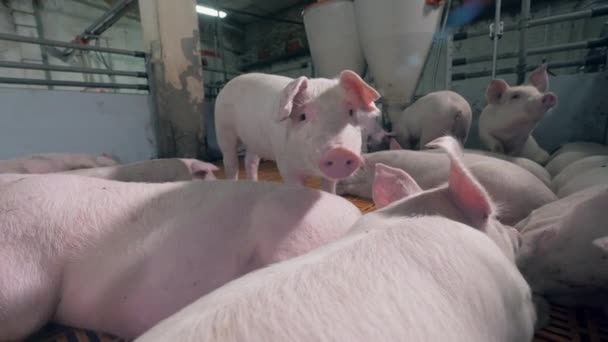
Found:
[139,0,207,158]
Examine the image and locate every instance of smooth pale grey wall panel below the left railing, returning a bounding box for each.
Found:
[0,88,156,162]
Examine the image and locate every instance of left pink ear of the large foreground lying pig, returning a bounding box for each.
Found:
[372,164,422,209]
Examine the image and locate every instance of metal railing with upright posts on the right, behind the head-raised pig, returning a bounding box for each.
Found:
[446,0,608,85]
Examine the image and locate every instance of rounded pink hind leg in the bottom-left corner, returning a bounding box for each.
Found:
[0,253,58,341]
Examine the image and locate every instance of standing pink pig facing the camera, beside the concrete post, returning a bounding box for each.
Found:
[215,70,380,193]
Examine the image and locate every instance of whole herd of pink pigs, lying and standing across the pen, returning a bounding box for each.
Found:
[0,66,608,342]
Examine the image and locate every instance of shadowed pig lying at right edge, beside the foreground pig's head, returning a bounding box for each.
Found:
[516,185,608,322]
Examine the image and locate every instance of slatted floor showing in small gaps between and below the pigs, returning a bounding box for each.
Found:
[27,162,608,342]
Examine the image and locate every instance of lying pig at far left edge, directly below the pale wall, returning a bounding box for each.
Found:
[0,153,118,173]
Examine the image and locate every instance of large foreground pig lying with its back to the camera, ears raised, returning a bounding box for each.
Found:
[136,136,535,342]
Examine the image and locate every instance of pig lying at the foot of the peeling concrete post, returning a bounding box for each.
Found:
[62,158,219,183]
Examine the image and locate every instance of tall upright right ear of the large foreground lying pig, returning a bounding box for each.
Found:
[426,136,495,228]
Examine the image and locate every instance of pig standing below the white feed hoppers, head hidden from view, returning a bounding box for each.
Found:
[389,90,472,149]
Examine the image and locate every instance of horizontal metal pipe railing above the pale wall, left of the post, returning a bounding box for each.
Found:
[0,33,149,91]
